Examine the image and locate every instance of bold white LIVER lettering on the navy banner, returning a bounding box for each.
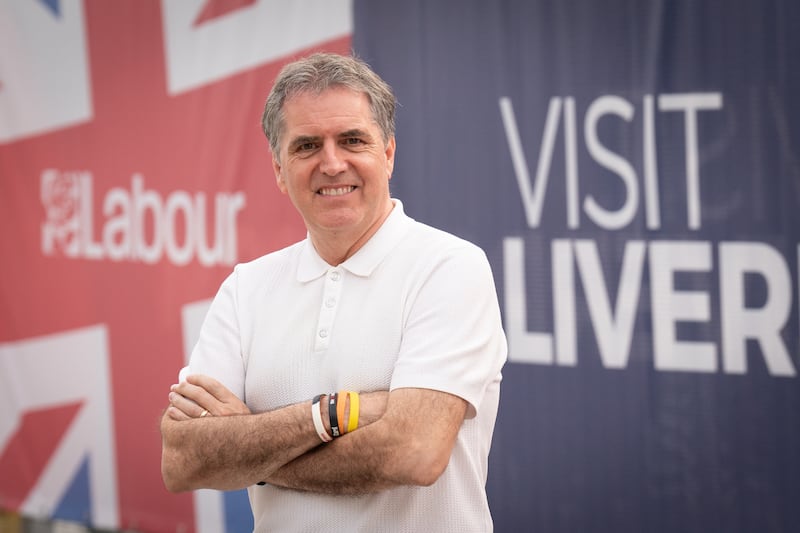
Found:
[503,237,800,376]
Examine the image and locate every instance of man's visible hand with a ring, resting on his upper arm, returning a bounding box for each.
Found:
[166,375,250,421]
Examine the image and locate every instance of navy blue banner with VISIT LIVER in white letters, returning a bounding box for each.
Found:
[353,0,800,533]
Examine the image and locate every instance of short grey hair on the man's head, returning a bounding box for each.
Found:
[261,52,397,159]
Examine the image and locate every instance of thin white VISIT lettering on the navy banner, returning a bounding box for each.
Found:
[499,93,722,230]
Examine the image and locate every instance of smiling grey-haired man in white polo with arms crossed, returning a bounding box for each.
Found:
[161,54,506,532]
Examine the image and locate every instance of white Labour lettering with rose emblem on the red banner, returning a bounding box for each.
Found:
[40,169,246,266]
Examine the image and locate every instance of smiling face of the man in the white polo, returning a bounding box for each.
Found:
[273,87,395,245]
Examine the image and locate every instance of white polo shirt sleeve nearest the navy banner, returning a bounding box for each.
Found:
[391,242,507,418]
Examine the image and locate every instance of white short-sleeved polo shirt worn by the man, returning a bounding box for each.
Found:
[182,200,506,532]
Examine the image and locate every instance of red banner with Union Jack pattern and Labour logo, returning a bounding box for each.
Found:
[0,0,352,531]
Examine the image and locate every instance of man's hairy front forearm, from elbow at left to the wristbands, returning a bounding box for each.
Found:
[161,402,320,491]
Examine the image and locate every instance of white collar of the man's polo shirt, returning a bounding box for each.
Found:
[297,198,414,283]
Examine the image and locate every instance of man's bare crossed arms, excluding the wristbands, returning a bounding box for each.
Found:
[161,376,467,494]
